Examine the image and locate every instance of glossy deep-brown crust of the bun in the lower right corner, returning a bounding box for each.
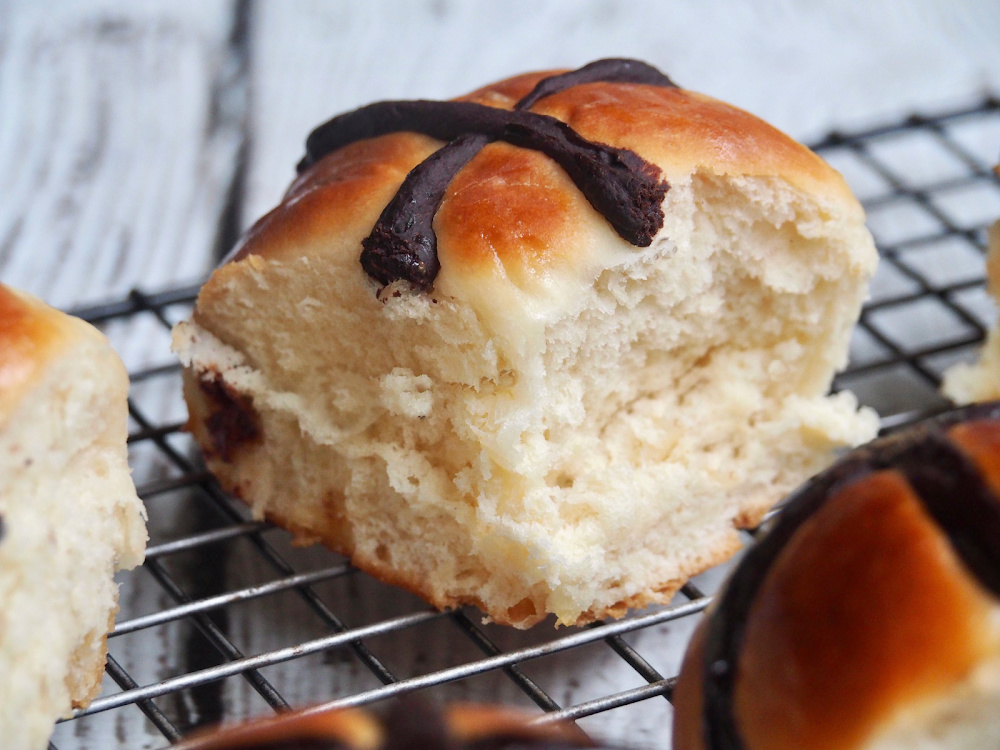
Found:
[688,470,996,750]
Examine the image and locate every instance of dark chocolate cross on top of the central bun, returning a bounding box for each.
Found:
[298,59,676,290]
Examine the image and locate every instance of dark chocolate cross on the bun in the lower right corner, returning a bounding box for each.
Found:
[702,403,1000,750]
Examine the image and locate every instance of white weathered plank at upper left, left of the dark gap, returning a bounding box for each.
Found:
[0,0,243,307]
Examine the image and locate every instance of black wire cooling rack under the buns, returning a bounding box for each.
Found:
[50,98,1000,750]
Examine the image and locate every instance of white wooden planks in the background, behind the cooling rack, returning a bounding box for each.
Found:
[0,0,1000,306]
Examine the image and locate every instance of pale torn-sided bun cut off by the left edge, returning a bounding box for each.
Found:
[0,285,146,750]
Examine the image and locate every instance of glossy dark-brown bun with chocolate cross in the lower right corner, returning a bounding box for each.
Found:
[673,403,1000,750]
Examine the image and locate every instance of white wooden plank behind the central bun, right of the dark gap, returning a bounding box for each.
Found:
[244,0,1000,222]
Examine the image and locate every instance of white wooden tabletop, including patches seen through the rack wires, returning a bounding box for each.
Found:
[0,0,1000,750]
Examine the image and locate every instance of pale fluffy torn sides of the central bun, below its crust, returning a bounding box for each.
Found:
[174,172,877,627]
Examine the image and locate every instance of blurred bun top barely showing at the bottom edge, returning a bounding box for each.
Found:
[177,700,594,750]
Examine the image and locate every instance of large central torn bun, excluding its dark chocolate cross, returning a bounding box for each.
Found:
[174,61,876,627]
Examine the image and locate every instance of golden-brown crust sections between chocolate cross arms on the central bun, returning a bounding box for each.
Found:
[217,73,858,284]
